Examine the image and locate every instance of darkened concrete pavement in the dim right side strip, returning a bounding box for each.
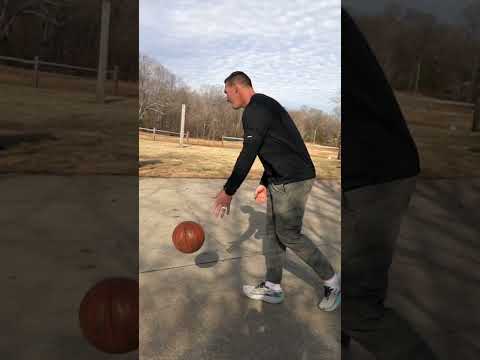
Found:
[344,178,480,360]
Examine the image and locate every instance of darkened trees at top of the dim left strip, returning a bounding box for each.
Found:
[0,0,138,81]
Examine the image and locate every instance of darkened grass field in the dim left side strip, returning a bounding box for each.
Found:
[0,83,138,174]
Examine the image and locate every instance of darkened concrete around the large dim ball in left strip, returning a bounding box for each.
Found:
[0,175,138,360]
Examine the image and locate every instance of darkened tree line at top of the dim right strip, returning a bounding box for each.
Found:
[353,1,480,103]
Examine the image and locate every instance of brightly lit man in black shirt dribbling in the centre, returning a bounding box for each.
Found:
[214,71,340,311]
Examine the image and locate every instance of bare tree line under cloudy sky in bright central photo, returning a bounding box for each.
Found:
[139,54,340,146]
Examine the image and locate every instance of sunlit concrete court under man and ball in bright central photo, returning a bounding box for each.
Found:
[139,178,340,360]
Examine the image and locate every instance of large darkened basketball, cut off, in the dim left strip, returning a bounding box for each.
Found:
[79,278,139,353]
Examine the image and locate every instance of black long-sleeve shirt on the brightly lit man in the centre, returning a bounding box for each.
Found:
[224,93,315,195]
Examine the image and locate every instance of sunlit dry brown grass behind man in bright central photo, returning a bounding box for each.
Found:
[139,134,340,179]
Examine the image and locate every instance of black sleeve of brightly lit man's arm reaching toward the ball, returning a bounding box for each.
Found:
[223,104,272,195]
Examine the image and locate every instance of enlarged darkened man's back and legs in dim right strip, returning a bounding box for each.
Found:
[342,9,435,360]
